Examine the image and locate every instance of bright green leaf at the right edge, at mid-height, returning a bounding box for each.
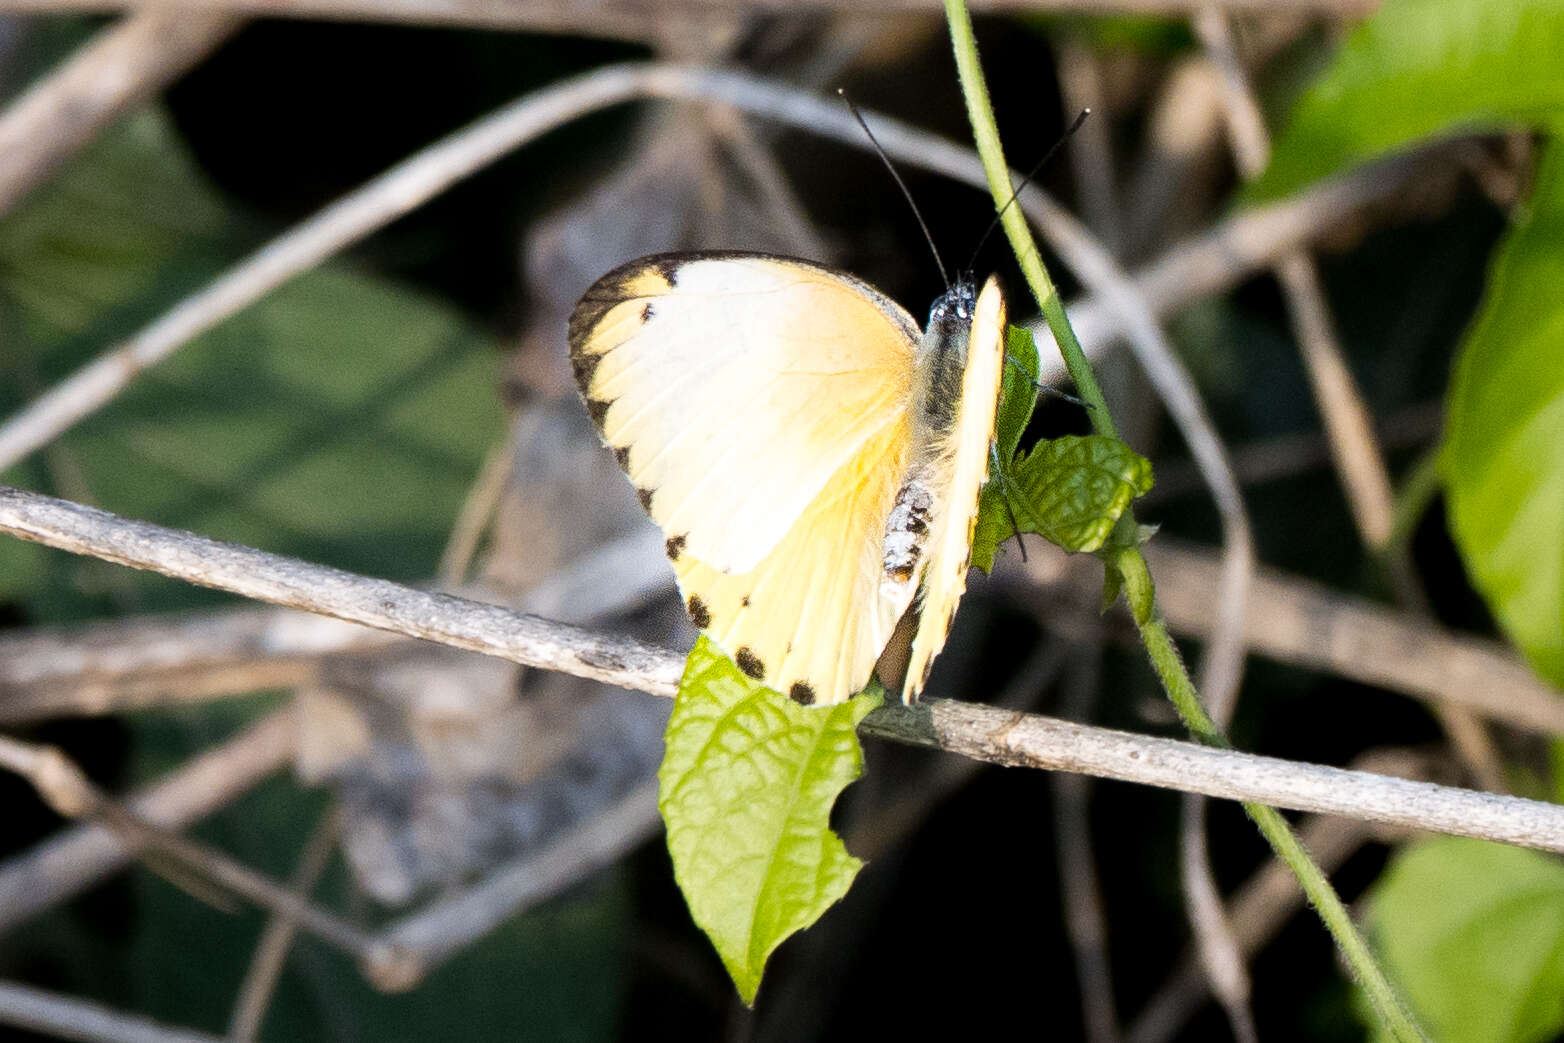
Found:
[1440,142,1564,685]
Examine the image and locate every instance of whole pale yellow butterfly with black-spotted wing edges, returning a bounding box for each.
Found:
[568,252,1006,705]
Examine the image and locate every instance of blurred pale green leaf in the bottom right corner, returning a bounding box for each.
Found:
[1369,837,1564,1043]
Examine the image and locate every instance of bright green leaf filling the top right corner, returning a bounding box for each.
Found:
[1250,0,1564,199]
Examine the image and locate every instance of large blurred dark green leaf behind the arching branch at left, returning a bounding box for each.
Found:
[0,109,504,619]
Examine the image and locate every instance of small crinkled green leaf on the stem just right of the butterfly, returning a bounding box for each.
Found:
[973,435,1151,572]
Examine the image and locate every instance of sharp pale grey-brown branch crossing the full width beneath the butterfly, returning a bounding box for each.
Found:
[0,486,1564,863]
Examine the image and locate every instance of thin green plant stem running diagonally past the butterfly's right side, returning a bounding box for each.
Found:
[945,0,1428,1043]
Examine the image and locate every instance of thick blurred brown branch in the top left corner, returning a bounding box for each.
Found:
[0,5,242,214]
